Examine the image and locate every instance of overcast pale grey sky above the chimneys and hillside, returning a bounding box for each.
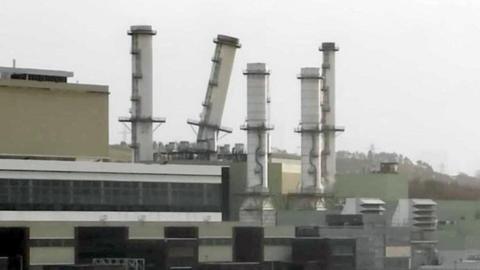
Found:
[0,0,480,173]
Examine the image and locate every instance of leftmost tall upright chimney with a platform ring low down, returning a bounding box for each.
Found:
[119,25,165,162]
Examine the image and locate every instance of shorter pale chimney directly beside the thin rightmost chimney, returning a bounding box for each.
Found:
[292,67,325,210]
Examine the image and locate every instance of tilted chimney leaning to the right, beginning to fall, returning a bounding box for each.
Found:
[187,35,240,160]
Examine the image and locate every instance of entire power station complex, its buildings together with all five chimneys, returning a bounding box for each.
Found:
[0,25,437,270]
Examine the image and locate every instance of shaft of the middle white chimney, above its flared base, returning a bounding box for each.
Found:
[244,63,271,192]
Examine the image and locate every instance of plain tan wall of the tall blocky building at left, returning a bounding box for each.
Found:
[0,80,108,157]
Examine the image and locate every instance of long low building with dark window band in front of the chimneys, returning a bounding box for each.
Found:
[0,157,424,269]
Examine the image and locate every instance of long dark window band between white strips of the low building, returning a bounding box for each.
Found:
[0,179,221,212]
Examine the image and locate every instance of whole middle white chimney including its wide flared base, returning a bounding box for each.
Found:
[240,63,276,224]
